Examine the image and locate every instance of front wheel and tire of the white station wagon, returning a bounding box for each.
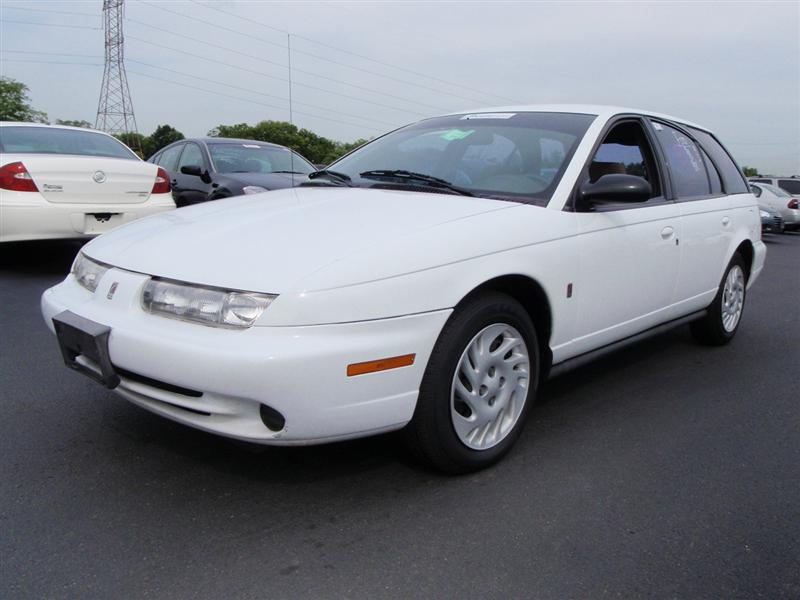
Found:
[405,292,540,473]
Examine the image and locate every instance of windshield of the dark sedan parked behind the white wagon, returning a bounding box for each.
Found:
[208,142,315,175]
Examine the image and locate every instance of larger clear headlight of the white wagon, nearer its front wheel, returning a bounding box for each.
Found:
[142,279,277,328]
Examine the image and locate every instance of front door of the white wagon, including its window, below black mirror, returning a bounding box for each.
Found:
[573,117,680,354]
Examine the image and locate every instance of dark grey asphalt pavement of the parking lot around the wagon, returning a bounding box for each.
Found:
[0,234,800,599]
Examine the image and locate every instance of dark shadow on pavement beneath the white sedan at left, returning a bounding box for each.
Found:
[0,240,86,275]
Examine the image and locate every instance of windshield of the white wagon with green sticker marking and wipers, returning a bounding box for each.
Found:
[329,112,595,204]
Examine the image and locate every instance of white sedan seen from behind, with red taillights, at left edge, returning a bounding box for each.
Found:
[0,122,175,242]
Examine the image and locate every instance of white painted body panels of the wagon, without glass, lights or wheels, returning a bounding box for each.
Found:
[42,106,766,444]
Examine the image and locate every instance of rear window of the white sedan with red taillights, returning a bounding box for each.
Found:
[0,127,139,160]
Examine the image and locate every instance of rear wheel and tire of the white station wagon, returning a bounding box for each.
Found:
[690,252,747,346]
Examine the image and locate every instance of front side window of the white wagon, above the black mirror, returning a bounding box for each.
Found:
[589,121,663,198]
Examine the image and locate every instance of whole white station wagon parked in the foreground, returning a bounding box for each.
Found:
[42,106,766,472]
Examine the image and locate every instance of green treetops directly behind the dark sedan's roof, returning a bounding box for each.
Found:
[208,121,365,165]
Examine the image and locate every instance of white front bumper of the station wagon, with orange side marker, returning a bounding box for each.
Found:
[42,269,451,444]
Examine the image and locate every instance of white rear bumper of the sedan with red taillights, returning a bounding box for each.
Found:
[0,190,175,242]
